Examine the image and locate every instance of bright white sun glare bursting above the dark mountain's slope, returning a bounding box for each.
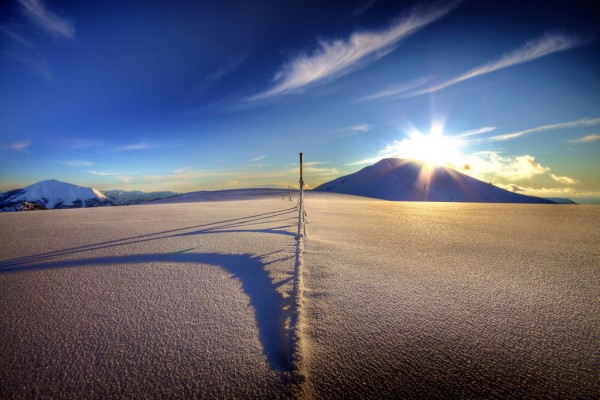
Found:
[390,125,463,166]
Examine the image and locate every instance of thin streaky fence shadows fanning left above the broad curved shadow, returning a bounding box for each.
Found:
[0,207,296,272]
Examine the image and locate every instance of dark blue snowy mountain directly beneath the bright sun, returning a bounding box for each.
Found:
[315,158,554,204]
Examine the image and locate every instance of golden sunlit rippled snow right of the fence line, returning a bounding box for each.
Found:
[304,192,600,398]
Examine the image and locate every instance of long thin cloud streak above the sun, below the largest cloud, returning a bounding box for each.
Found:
[364,33,584,100]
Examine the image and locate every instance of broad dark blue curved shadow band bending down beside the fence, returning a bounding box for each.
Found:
[2,250,291,373]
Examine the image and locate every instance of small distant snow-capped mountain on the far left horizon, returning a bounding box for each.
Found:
[0,179,114,211]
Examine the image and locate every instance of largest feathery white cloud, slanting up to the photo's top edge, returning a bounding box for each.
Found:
[248,1,459,100]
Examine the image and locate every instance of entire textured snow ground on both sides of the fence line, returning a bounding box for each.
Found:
[0,193,600,398]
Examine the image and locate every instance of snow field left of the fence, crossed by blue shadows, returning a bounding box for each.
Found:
[0,197,297,398]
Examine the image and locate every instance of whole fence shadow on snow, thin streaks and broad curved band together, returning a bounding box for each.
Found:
[0,207,295,372]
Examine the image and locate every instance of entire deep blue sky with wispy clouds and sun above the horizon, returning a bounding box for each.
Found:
[0,0,600,198]
